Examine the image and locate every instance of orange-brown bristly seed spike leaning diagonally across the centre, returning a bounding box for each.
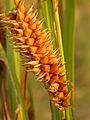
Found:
[0,0,71,110]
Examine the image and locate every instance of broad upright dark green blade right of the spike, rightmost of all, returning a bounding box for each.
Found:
[64,0,75,120]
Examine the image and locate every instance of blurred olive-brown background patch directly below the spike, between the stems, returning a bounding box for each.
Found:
[28,73,51,120]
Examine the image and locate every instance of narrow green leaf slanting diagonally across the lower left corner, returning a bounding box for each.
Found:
[0,44,28,120]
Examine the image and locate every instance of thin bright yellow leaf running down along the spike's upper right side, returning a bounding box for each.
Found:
[52,0,65,120]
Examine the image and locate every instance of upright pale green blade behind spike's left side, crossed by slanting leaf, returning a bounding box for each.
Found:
[6,0,18,119]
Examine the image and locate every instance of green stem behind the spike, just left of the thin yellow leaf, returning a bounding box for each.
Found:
[39,0,59,120]
